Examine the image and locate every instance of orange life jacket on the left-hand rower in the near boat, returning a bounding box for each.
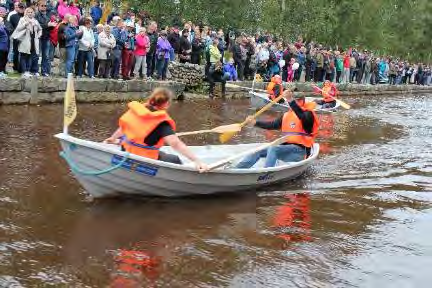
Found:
[119,101,176,159]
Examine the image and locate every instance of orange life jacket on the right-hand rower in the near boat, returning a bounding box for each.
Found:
[282,102,319,148]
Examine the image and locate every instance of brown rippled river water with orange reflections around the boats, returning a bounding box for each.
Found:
[0,95,432,287]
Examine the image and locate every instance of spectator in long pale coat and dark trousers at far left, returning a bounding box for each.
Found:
[11,8,42,78]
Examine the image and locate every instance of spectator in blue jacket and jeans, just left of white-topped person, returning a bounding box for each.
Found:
[64,15,83,78]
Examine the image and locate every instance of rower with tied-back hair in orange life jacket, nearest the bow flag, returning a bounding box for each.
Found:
[104,88,207,172]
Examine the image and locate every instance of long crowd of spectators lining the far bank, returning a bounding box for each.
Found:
[0,0,431,90]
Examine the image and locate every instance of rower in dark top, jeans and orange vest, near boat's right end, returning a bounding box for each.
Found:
[236,90,319,169]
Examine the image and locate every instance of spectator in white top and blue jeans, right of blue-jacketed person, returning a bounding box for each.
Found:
[78,18,95,78]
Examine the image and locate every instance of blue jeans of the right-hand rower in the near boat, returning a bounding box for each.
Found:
[236,144,307,169]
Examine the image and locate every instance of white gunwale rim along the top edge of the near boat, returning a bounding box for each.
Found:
[54,133,319,175]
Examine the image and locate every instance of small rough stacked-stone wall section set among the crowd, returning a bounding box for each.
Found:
[168,62,205,87]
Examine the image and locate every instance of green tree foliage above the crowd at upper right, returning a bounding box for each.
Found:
[126,0,432,62]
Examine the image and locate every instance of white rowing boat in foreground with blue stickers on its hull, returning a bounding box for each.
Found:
[55,133,319,198]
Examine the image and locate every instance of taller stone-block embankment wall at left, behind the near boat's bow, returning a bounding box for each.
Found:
[0,78,185,104]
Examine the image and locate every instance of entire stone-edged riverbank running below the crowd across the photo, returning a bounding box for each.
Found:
[0,77,432,105]
